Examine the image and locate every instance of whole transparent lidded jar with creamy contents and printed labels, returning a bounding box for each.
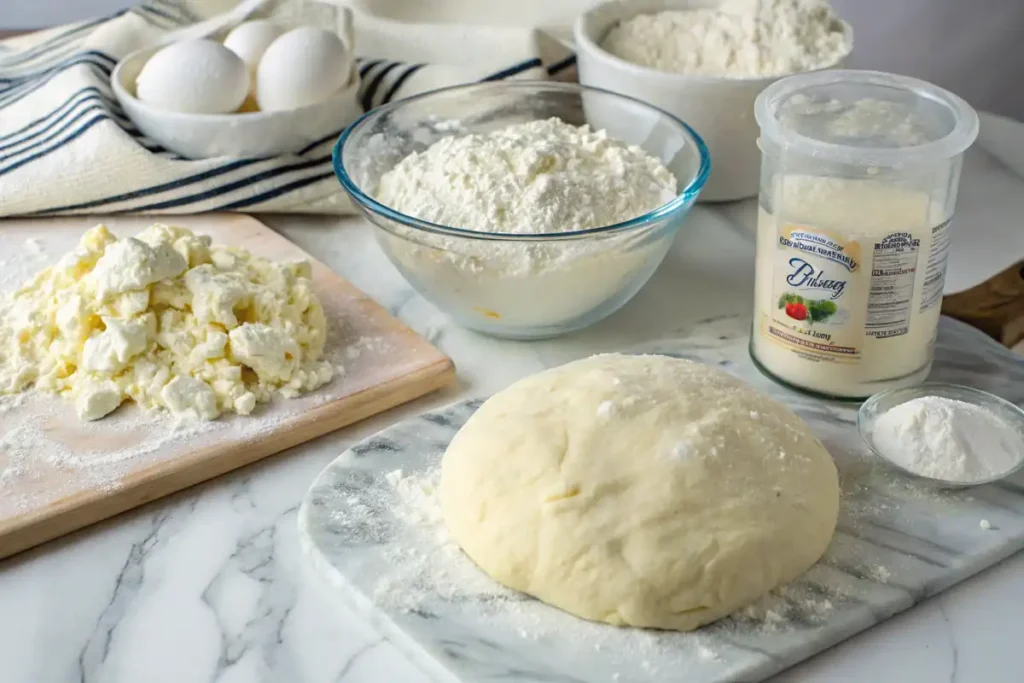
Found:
[751,71,978,399]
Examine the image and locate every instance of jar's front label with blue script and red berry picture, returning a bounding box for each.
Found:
[762,223,870,362]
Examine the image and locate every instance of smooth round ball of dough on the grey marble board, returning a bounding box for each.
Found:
[440,354,839,631]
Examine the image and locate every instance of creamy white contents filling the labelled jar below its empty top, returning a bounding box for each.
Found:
[751,175,949,397]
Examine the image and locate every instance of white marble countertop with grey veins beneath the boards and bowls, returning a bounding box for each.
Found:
[0,117,1024,683]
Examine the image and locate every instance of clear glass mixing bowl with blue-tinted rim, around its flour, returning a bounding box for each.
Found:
[334,81,711,339]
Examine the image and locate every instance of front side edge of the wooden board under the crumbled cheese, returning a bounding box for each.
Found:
[0,353,455,559]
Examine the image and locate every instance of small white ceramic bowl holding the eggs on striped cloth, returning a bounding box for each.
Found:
[111,47,362,159]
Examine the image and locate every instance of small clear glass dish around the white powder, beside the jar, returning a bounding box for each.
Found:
[857,382,1024,488]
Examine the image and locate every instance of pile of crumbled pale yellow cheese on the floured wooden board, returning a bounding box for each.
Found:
[0,224,334,420]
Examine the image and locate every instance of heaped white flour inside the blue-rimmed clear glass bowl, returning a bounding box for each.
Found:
[377,119,677,234]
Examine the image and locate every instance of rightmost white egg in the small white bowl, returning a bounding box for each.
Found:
[256,27,352,112]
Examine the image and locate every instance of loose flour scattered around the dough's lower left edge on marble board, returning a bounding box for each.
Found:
[350,466,845,676]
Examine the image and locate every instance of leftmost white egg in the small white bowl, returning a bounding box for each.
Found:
[135,40,249,114]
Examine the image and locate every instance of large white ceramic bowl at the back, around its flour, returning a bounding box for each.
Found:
[573,0,853,202]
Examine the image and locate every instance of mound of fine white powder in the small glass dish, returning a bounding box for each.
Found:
[871,396,1024,482]
